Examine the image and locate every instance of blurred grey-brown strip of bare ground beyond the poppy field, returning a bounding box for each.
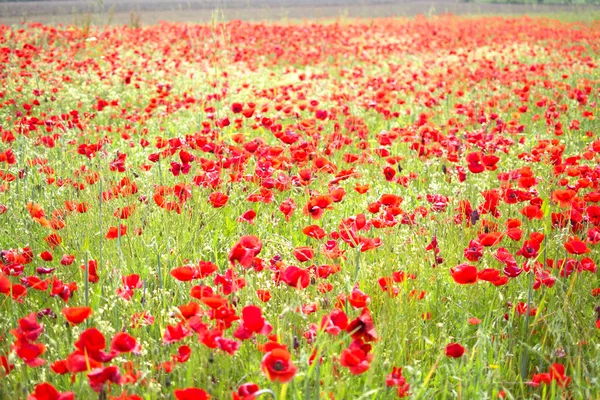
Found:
[0,0,600,25]
